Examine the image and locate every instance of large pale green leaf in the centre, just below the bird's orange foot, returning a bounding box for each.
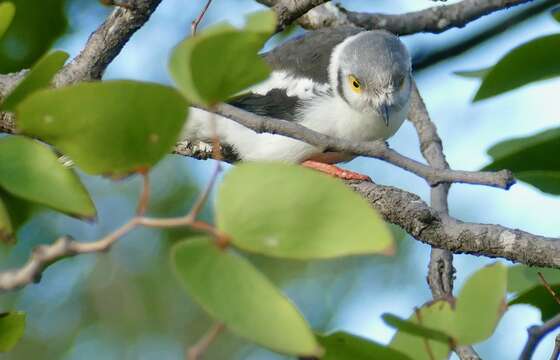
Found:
[216,163,393,259]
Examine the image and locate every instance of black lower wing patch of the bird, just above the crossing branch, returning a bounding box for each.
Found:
[229,89,301,121]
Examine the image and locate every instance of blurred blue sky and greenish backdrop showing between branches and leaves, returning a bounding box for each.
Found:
[0,0,560,360]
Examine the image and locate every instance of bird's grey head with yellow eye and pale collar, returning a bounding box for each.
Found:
[329,30,412,125]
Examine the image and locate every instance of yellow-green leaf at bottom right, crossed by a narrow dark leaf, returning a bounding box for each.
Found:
[389,300,454,360]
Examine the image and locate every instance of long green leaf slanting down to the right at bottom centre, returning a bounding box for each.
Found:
[172,237,322,356]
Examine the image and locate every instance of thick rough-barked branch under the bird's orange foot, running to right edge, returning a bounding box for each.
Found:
[172,142,560,268]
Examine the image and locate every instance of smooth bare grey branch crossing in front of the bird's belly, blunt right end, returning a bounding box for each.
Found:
[198,104,514,189]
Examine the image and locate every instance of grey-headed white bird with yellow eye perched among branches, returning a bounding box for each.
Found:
[182,27,412,180]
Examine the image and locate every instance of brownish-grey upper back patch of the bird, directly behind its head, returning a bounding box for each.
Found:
[264,27,363,84]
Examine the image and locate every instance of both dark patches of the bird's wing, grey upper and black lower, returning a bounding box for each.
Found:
[229,27,363,121]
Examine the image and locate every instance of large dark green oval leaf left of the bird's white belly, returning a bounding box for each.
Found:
[16,80,188,176]
